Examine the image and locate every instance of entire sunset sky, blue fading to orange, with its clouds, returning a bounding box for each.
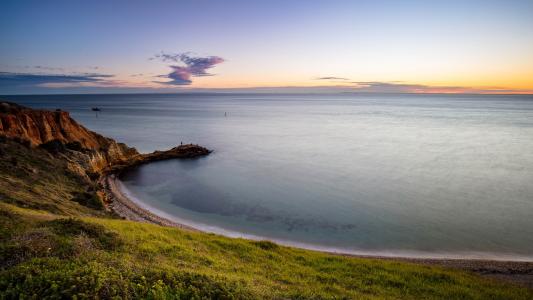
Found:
[0,0,533,94]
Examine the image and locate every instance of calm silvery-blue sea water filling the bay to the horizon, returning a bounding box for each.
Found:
[7,94,533,259]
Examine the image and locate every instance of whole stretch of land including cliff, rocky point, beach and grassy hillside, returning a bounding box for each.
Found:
[0,103,533,299]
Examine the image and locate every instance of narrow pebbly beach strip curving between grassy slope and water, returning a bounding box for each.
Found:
[105,174,533,289]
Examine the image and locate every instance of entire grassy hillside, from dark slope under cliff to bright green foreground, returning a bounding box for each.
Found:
[0,141,533,299]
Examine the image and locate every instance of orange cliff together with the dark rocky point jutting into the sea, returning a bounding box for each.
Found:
[0,102,210,177]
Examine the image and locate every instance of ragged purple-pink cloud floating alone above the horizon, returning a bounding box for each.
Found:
[151,52,224,85]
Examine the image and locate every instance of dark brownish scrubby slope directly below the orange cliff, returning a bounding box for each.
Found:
[0,137,106,216]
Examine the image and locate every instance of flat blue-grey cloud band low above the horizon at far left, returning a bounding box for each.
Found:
[0,72,113,87]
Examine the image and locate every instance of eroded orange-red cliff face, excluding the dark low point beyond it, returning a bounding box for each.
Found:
[0,102,139,174]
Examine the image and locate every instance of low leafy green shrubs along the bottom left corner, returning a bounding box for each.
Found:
[0,258,251,299]
